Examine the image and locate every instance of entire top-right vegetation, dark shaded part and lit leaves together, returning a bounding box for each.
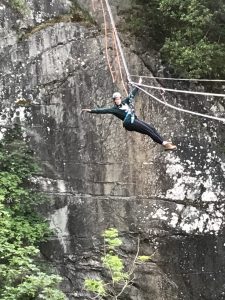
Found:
[125,0,225,78]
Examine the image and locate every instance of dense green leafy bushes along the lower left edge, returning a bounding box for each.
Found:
[0,127,66,300]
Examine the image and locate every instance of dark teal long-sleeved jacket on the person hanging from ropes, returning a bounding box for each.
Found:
[90,87,138,121]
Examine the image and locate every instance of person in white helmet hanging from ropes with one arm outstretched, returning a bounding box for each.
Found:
[82,78,177,150]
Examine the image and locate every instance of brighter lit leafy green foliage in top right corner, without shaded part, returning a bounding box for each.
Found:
[160,0,225,78]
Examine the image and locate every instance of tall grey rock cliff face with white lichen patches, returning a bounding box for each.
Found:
[0,0,225,300]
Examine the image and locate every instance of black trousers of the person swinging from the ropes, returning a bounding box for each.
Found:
[123,119,163,144]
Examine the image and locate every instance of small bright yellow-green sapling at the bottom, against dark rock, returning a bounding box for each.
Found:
[84,228,151,300]
